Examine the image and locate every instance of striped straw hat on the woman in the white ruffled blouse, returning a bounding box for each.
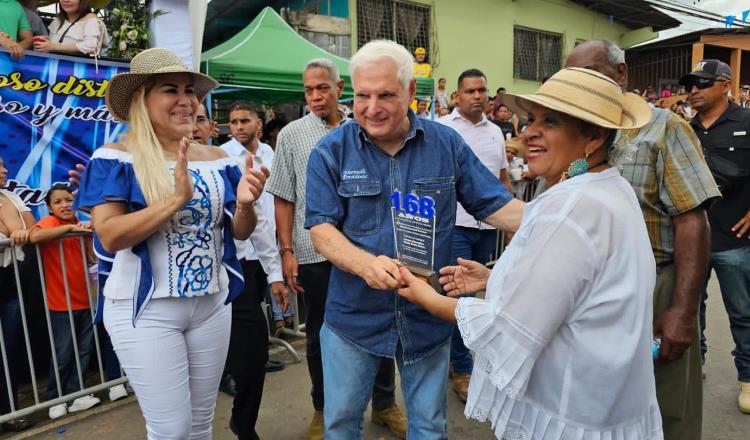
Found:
[503,67,651,129]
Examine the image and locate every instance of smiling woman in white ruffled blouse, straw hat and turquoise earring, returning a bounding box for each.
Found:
[399,69,663,440]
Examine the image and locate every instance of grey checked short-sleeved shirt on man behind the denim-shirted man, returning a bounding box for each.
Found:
[265,113,346,264]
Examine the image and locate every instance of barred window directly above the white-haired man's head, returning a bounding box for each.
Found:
[357,0,432,58]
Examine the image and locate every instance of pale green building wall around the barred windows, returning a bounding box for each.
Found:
[349,0,653,94]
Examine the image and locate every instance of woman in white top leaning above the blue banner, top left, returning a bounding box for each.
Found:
[34,0,109,57]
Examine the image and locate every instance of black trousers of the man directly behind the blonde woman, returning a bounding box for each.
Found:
[225,260,268,440]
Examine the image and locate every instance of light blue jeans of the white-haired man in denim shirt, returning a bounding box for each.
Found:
[320,324,449,440]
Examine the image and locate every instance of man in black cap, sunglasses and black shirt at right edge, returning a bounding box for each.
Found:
[680,59,750,414]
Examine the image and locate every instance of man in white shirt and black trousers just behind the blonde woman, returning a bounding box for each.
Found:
[220,101,288,438]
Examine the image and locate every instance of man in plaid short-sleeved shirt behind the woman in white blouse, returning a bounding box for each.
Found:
[566,40,720,440]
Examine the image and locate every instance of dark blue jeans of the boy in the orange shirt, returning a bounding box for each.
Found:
[47,309,94,400]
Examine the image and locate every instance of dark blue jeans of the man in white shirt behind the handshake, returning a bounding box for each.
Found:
[451,226,497,373]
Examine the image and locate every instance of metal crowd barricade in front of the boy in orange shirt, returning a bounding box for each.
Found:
[0,232,128,423]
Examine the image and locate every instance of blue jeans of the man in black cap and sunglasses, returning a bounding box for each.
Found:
[711,246,750,382]
